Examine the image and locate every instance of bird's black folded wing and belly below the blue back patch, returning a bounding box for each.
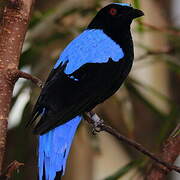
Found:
[30,59,132,134]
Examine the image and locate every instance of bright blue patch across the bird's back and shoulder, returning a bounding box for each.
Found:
[54,30,124,74]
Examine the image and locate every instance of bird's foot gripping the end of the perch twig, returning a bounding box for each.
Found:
[84,111,104,134]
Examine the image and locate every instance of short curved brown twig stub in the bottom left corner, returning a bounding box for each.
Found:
[0,160,24,180]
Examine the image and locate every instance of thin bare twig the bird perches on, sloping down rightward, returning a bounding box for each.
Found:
[84,112,180,173]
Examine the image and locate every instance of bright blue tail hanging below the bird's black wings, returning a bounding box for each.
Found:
[39,116,81,180]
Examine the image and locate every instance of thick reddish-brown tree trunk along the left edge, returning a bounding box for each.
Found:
[0,0,33,172]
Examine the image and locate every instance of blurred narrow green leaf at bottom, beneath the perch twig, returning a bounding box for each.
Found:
[104,160,142,180]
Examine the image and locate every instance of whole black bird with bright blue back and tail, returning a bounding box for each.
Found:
[29,3,143,180]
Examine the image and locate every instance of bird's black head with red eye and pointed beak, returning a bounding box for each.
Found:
[88,3,144,30]
